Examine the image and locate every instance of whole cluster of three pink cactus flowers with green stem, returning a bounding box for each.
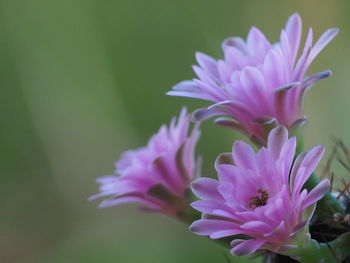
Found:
[90,14,350,263]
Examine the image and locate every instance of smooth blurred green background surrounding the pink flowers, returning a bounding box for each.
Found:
[0,0,350,263]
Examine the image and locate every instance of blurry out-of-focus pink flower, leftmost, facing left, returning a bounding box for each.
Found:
[90,108,200,218]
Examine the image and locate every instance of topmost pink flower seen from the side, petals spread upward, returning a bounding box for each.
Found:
[167,14,338,145]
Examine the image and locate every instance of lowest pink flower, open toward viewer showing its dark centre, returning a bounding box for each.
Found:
[190,126,330,255]
